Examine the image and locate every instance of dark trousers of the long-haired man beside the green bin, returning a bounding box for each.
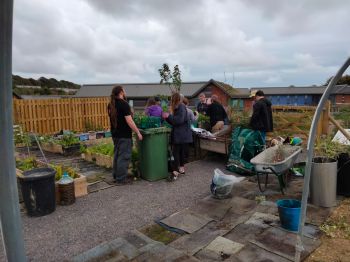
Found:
[113,138,132,182]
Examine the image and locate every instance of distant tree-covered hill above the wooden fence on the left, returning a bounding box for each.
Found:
[12,75,80,95]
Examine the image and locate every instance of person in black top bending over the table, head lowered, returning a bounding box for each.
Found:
[207,95,227,133]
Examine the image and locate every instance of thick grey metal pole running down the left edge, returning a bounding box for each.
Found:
[0,0,26,262]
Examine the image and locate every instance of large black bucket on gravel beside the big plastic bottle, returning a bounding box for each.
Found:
[18,167,56,217]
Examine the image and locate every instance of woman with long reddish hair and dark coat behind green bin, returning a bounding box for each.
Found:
[165,93,193,181]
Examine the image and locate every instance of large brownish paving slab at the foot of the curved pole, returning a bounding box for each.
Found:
[250,227,321,261]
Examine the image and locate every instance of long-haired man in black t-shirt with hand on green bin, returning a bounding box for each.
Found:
[108,86,142,185]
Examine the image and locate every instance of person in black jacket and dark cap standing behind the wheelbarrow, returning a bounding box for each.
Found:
[250,90,273,141]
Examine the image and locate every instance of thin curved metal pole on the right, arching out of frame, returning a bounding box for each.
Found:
[294,57,350,262]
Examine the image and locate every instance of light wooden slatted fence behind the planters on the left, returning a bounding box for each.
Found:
[13,97,109,134]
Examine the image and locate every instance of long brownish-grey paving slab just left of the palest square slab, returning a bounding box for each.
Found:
[169,221,228,255]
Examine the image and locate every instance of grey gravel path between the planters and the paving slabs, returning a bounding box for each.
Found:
[0,158,225,261]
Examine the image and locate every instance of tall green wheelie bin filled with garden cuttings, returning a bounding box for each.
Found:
[138,127,170,181]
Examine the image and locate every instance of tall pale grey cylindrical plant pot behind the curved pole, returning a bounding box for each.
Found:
[310,157,337,207]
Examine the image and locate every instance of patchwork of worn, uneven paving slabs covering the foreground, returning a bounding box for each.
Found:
[72,170,331,262]
